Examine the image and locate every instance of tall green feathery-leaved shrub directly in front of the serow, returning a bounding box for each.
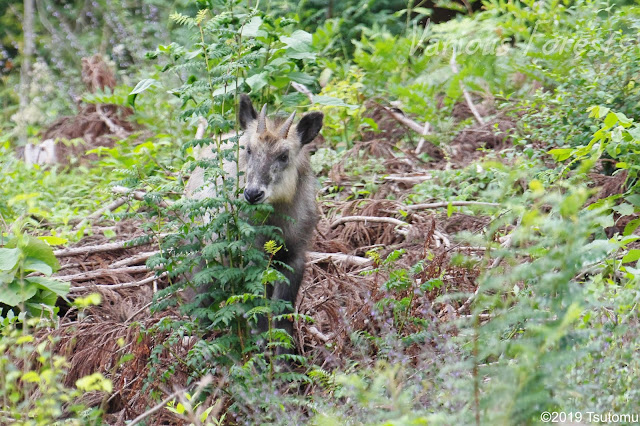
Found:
[126,1,324,418]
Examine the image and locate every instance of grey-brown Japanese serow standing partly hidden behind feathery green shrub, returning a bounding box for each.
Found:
[186,95,324,348]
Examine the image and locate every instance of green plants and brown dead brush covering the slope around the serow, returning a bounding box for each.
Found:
[0,0,640,425]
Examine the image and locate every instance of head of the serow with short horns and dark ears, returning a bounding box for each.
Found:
[238,95,323,204]
